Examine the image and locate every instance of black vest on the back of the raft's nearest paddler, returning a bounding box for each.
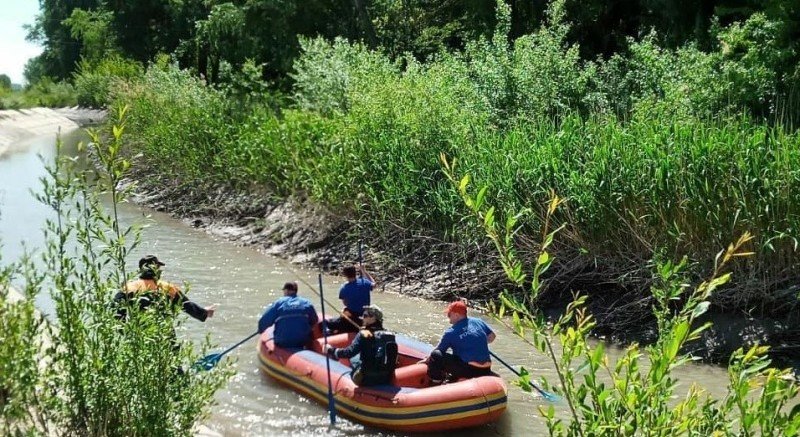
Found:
[353,330,397,385]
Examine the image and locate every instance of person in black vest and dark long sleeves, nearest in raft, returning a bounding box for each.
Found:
[325,305,397,386]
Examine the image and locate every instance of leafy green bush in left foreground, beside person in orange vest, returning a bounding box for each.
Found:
[0,110,231,436]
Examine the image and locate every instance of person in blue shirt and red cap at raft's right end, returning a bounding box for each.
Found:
[422,300,496,384]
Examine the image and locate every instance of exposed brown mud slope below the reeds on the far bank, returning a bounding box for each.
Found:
[119,165,800,367]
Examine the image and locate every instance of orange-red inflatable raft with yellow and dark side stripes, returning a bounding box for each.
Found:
[258,328,507,432]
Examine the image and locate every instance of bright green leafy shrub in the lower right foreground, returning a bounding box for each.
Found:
[443,164,800,436]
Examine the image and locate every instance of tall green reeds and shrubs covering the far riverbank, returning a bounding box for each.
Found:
[114,3,800,348]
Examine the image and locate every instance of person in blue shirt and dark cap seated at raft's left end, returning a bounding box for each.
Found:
[258,282,319,348]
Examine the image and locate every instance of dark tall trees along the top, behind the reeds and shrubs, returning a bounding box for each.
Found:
[21,0,800,92]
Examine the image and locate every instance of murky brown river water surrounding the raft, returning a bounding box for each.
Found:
[0,134,727,436]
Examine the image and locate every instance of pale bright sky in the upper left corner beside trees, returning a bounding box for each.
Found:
[0,0,42,84]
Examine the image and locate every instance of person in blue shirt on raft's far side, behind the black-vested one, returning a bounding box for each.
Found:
[325,265,375,334]
